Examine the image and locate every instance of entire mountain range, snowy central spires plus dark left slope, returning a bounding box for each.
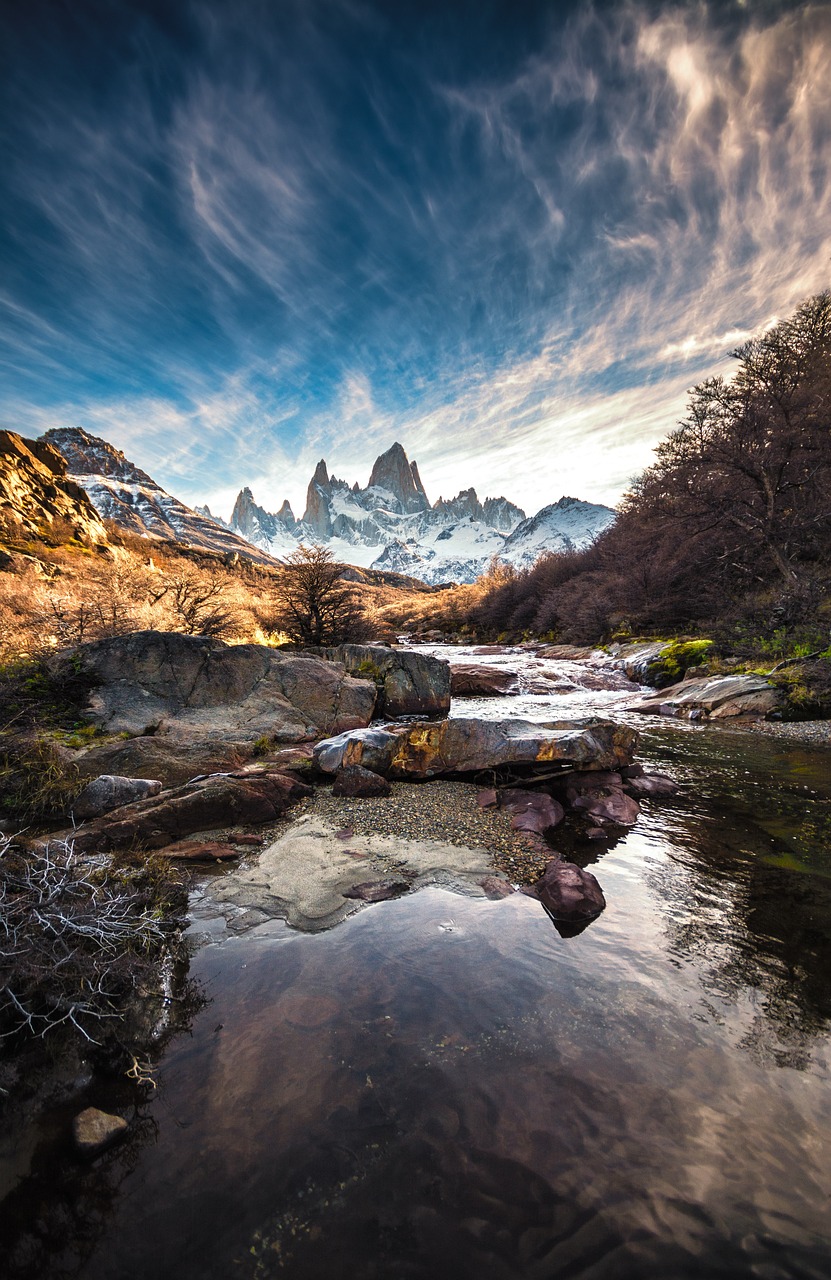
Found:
[42,428,615,585]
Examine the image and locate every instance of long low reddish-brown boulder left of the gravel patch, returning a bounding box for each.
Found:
[65,772,310,852]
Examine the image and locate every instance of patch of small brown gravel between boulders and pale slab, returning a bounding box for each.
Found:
[300,782,554,883]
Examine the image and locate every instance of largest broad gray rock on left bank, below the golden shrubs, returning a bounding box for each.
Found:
[76,631,375,742]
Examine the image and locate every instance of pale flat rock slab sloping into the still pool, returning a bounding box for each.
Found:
[206,815,504,933]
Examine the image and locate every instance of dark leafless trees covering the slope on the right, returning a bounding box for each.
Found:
[472,293,831,658]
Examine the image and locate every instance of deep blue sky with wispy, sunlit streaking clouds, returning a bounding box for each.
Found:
[0,0,831,518]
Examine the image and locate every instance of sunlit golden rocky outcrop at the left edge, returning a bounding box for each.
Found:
[0,431,108,545]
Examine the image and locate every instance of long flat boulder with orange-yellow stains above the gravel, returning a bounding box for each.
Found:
[315,719,638,778]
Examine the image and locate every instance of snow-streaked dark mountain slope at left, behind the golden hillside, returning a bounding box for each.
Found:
[42,426,274,563]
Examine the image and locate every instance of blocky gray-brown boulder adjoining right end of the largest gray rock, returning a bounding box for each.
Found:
[303,644,451,716]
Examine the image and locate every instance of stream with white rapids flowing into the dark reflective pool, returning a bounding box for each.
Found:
[4,646,831,1280]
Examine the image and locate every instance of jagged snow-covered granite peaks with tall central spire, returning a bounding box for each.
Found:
[230,443,615,585]
